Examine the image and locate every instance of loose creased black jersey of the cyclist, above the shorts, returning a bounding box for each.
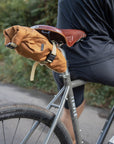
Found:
[57,0,114,69]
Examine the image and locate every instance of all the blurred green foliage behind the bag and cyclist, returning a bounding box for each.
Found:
[0,0,114,108]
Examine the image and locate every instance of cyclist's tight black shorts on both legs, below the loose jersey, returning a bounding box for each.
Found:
[54,58,114,109]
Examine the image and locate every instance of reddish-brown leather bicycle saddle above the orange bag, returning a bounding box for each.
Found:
[31,25,86,47]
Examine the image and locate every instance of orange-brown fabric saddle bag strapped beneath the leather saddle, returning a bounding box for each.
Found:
[3,25,67,73]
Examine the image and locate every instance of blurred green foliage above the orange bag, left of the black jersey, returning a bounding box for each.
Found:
[0,0,57,29]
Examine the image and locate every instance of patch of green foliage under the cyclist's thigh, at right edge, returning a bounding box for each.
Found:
[85,83,114,108]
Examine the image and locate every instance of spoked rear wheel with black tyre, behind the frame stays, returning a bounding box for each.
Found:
[0,104,72,144]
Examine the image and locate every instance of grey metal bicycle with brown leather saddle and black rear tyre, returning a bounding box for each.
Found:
[0,25,114,144]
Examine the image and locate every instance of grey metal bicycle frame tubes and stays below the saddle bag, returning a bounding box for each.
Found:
[21,49,114,144]
